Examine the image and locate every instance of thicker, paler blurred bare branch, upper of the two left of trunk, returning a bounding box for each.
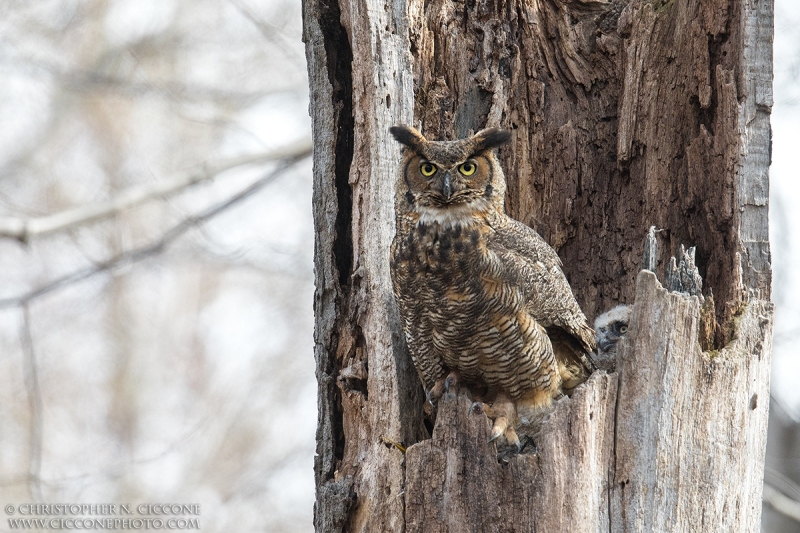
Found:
[0,138,311,242]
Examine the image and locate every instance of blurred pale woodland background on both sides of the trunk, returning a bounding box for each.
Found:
[0,0,800,532]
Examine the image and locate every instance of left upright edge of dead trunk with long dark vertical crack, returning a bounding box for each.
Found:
[304,1,424,531]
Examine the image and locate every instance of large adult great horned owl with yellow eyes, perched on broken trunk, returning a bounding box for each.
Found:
[390,126,595,448]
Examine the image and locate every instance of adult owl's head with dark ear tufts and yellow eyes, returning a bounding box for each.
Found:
[389,126,511,213]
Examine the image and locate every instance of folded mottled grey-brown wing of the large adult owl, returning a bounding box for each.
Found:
[488,217,595,372]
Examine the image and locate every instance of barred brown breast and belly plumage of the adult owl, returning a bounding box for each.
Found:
[392,212,571,398]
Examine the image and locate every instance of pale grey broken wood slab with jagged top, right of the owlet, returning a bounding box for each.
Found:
[610,272,773,531]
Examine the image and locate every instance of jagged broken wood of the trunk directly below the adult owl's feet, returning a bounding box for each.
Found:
[405,373,617,533]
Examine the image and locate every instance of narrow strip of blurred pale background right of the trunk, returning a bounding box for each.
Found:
[762,0,800,533]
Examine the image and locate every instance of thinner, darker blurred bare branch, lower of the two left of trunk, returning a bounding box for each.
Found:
[0,151,309,309]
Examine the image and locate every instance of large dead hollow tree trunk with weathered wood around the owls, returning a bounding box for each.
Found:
[304,0,773,532]
